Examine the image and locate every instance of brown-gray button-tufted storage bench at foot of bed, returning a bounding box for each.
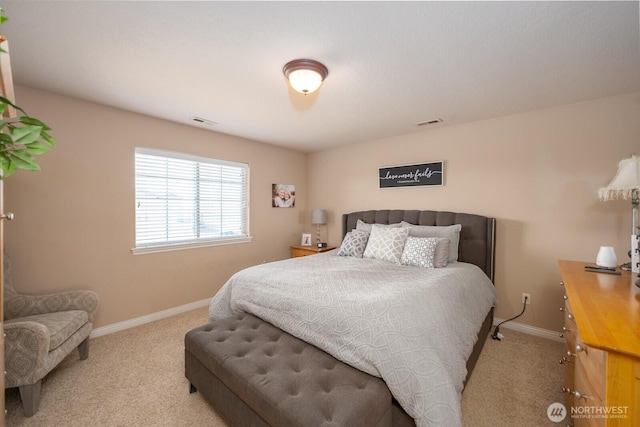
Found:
[185,313,391,427]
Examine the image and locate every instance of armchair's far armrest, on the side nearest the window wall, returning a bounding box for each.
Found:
[4,290,98,322]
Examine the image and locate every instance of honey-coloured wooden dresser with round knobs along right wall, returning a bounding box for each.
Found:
[558,260,640,427]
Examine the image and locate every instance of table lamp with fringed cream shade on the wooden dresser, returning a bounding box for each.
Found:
[598,155,640,286]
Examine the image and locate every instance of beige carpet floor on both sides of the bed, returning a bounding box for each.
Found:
[6,308,563,427]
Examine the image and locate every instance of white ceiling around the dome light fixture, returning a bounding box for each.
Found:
[2,0,640,152]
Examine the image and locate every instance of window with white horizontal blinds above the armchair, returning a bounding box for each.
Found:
[133,148,251,254]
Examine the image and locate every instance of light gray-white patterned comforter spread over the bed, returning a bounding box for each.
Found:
[209,251,496,427]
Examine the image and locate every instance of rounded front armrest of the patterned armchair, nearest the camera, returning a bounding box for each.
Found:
[4,320,50,387]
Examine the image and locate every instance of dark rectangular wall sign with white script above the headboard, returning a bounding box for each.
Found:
[378,161,444,188]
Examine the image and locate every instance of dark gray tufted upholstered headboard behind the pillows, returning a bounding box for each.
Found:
[342,210,496,282]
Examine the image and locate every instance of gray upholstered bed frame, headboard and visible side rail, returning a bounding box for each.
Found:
[342,210,496,427]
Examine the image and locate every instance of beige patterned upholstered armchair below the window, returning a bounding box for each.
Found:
[3,254,98,417]
